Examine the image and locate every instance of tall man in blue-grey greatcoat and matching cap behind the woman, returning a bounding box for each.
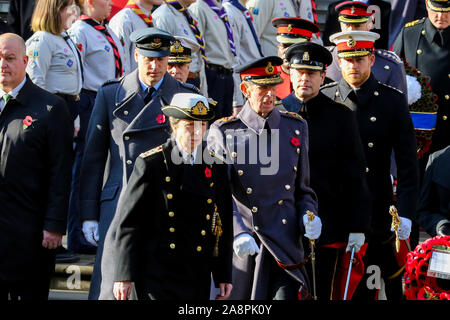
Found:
[80,28,199,299]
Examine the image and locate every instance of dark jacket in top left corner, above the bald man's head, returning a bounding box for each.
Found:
[8,0,36,41]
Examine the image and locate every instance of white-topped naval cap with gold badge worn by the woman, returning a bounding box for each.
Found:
[161,93,214,121]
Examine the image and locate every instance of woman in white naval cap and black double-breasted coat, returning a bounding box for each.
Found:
[114,93,233,300]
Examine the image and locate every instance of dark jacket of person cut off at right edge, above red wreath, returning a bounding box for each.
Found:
[417,147,450,237]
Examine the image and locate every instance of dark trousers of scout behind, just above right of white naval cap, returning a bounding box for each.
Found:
[205,68,234,119]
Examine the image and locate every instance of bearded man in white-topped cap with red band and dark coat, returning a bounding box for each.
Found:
[322,31,418,300]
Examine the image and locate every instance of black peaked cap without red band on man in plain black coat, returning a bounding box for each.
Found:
[286,42,333,71]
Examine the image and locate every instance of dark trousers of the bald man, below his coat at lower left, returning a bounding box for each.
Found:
[0,248,55,301]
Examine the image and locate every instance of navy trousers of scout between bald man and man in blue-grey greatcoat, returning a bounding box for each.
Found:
[67,90,96,253]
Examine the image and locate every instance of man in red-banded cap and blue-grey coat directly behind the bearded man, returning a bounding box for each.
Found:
[327,1,407,98]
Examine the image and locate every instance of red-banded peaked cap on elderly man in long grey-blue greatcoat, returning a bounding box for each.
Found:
[235,56,283,86]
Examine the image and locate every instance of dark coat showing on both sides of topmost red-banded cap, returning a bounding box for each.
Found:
[322,0,391,49]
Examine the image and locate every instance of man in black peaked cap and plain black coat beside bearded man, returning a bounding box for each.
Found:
[282,42,371,300]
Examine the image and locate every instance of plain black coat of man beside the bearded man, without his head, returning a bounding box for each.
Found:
[282,93,371,244]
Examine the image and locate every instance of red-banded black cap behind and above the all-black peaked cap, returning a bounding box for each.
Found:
[272,17,320,44]
